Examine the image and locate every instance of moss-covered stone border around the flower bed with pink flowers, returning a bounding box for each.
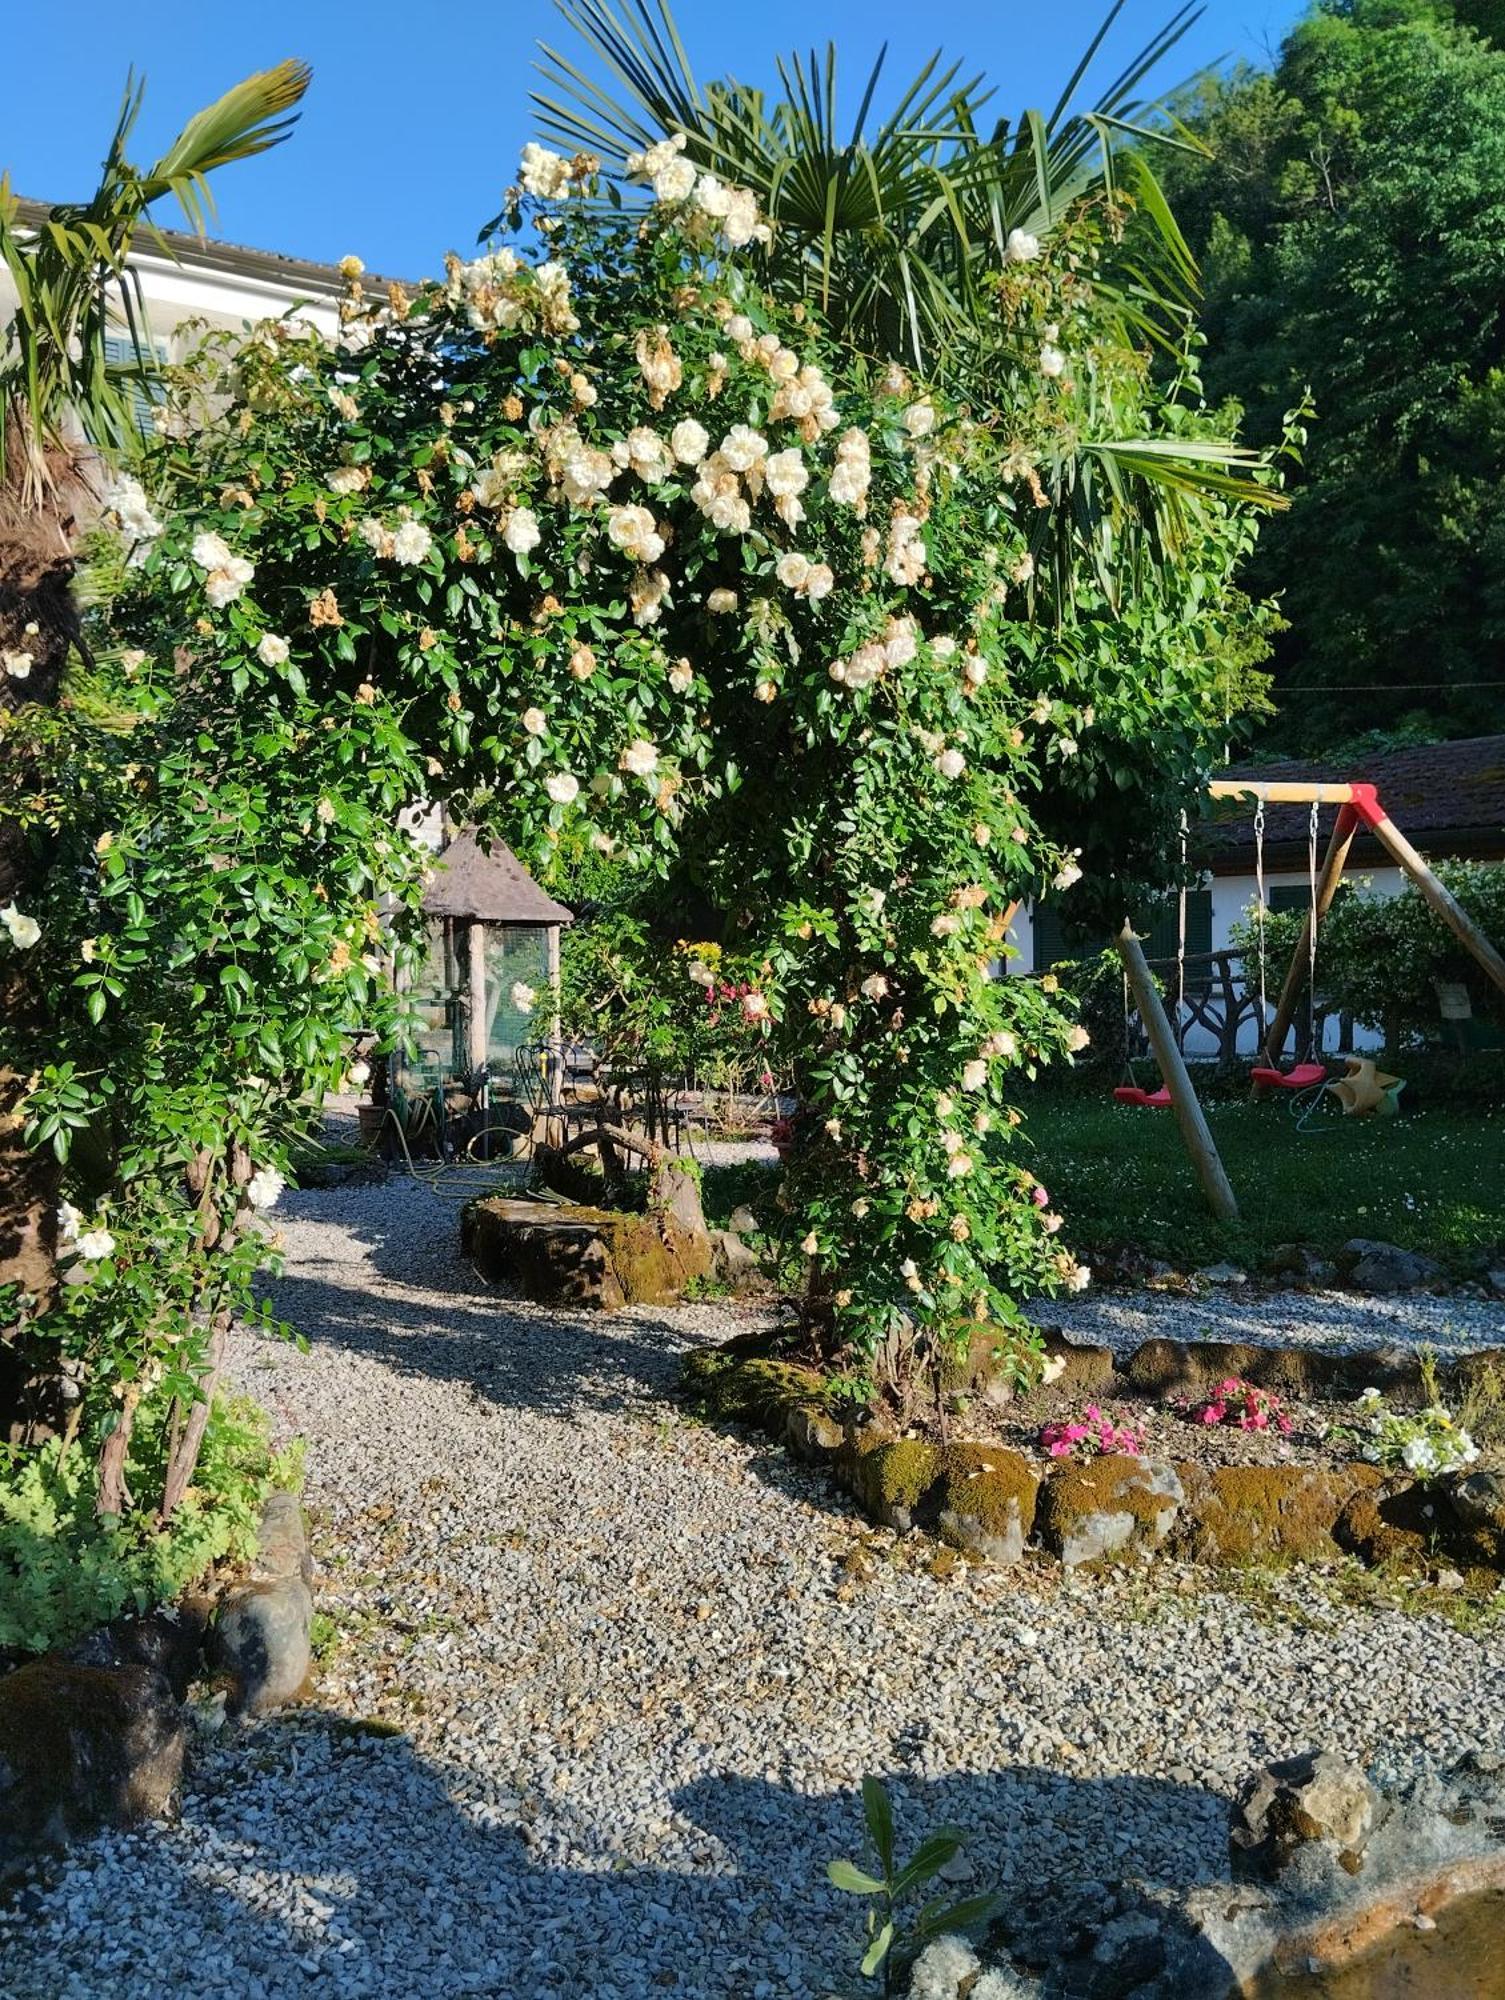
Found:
[682,1334,1505,1586]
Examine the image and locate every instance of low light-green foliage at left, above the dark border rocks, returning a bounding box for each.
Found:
[0,1402,300,1652]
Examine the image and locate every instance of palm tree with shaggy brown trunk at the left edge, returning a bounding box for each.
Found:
[0,62,310,1376]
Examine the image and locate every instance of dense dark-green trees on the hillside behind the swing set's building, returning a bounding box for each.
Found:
[1163,0,1505,750]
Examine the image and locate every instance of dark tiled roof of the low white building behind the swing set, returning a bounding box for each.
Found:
[1209,736,1505,856]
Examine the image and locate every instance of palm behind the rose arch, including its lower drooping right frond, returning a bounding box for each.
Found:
[532,0,1283,624]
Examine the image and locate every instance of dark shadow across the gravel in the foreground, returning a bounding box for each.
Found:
[0,1708,1227,2000]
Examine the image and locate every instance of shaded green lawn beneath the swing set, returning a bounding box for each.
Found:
[1021,1092,1505,1276]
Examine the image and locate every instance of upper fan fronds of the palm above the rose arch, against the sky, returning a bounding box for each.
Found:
[534,0,1201,378]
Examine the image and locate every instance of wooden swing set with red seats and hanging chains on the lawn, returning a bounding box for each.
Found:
[1113,778,1505,1222]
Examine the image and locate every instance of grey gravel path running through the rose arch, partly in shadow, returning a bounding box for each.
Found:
[11,1182,1505,2000]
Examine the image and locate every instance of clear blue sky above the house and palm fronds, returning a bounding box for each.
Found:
[0,0,1301,278]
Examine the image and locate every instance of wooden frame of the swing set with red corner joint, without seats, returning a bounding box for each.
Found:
[1115,778,1505,1222]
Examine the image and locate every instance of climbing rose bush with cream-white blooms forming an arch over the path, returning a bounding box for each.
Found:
[12,140,1280,1440]
